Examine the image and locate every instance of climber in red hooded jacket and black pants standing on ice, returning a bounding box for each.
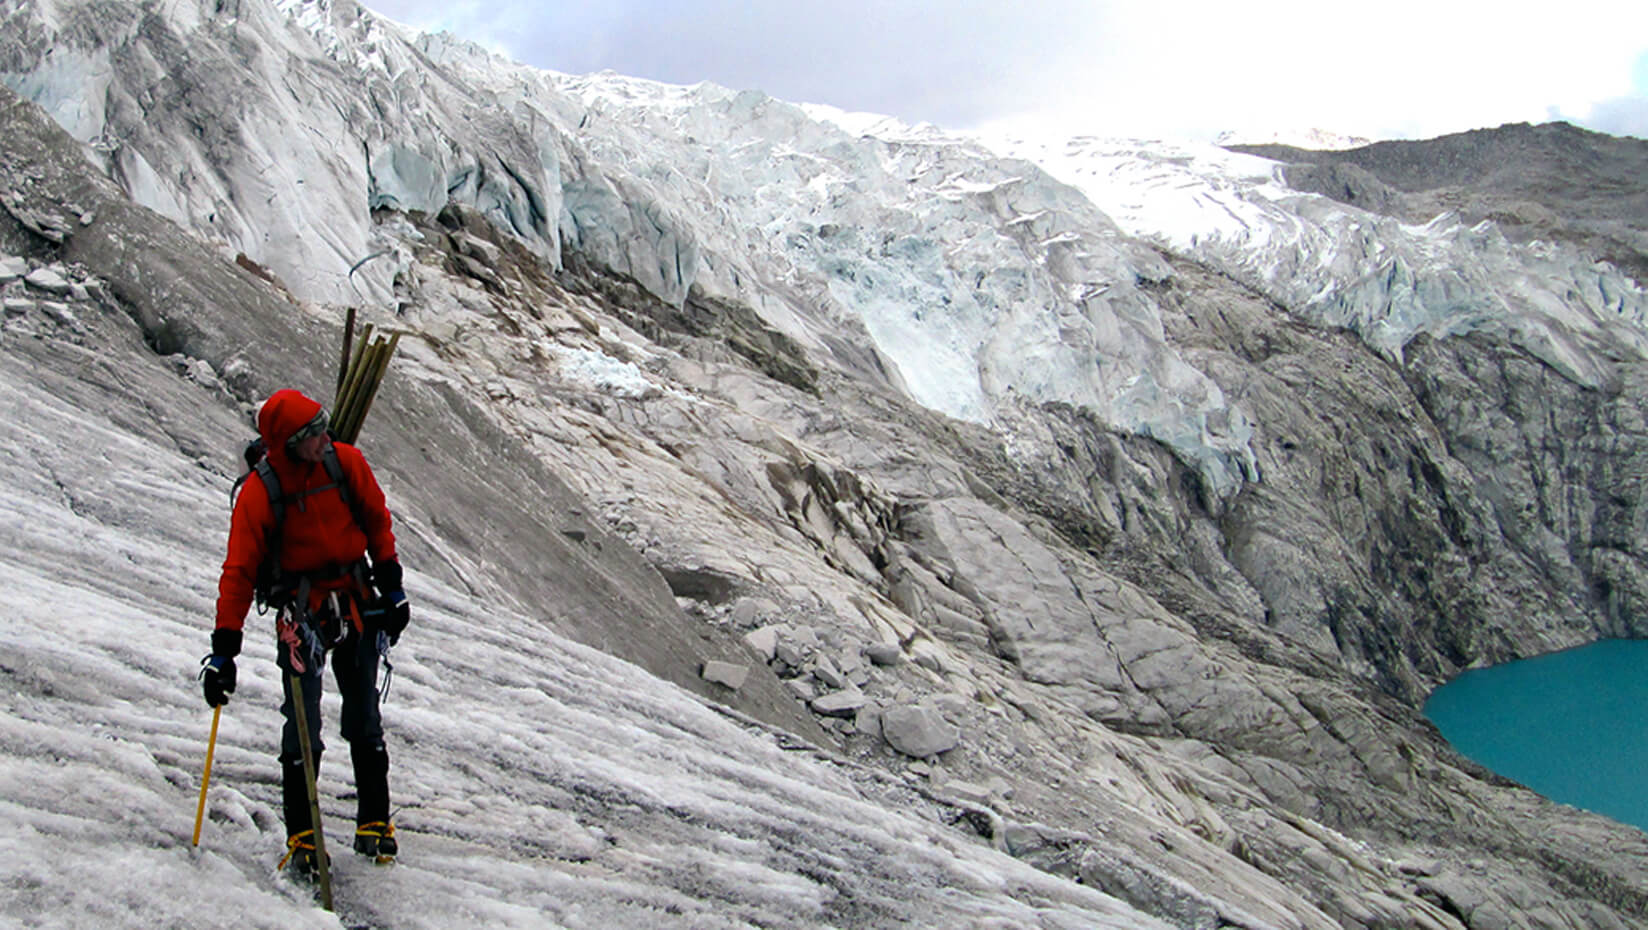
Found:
[201,391,409,876]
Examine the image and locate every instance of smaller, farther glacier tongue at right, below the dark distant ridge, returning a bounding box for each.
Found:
[992,139,1648,388]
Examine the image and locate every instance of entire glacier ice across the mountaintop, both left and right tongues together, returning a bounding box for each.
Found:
[3,0,1648,500]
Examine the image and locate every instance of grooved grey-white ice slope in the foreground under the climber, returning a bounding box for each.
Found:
[0,305,1159,928]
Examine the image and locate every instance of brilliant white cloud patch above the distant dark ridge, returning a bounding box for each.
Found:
[1028,0,1648,137]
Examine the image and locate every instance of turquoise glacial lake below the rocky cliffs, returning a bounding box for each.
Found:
[1424,640,1648,831]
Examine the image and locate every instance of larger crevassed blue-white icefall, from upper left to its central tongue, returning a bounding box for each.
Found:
[5,0,1252,495]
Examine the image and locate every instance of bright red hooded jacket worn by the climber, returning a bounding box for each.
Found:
[218,389,396,630]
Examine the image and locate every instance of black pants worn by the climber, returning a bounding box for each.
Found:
[279,616,389,836]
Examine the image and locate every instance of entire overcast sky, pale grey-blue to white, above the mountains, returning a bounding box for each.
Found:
[364,0,1648,139]
